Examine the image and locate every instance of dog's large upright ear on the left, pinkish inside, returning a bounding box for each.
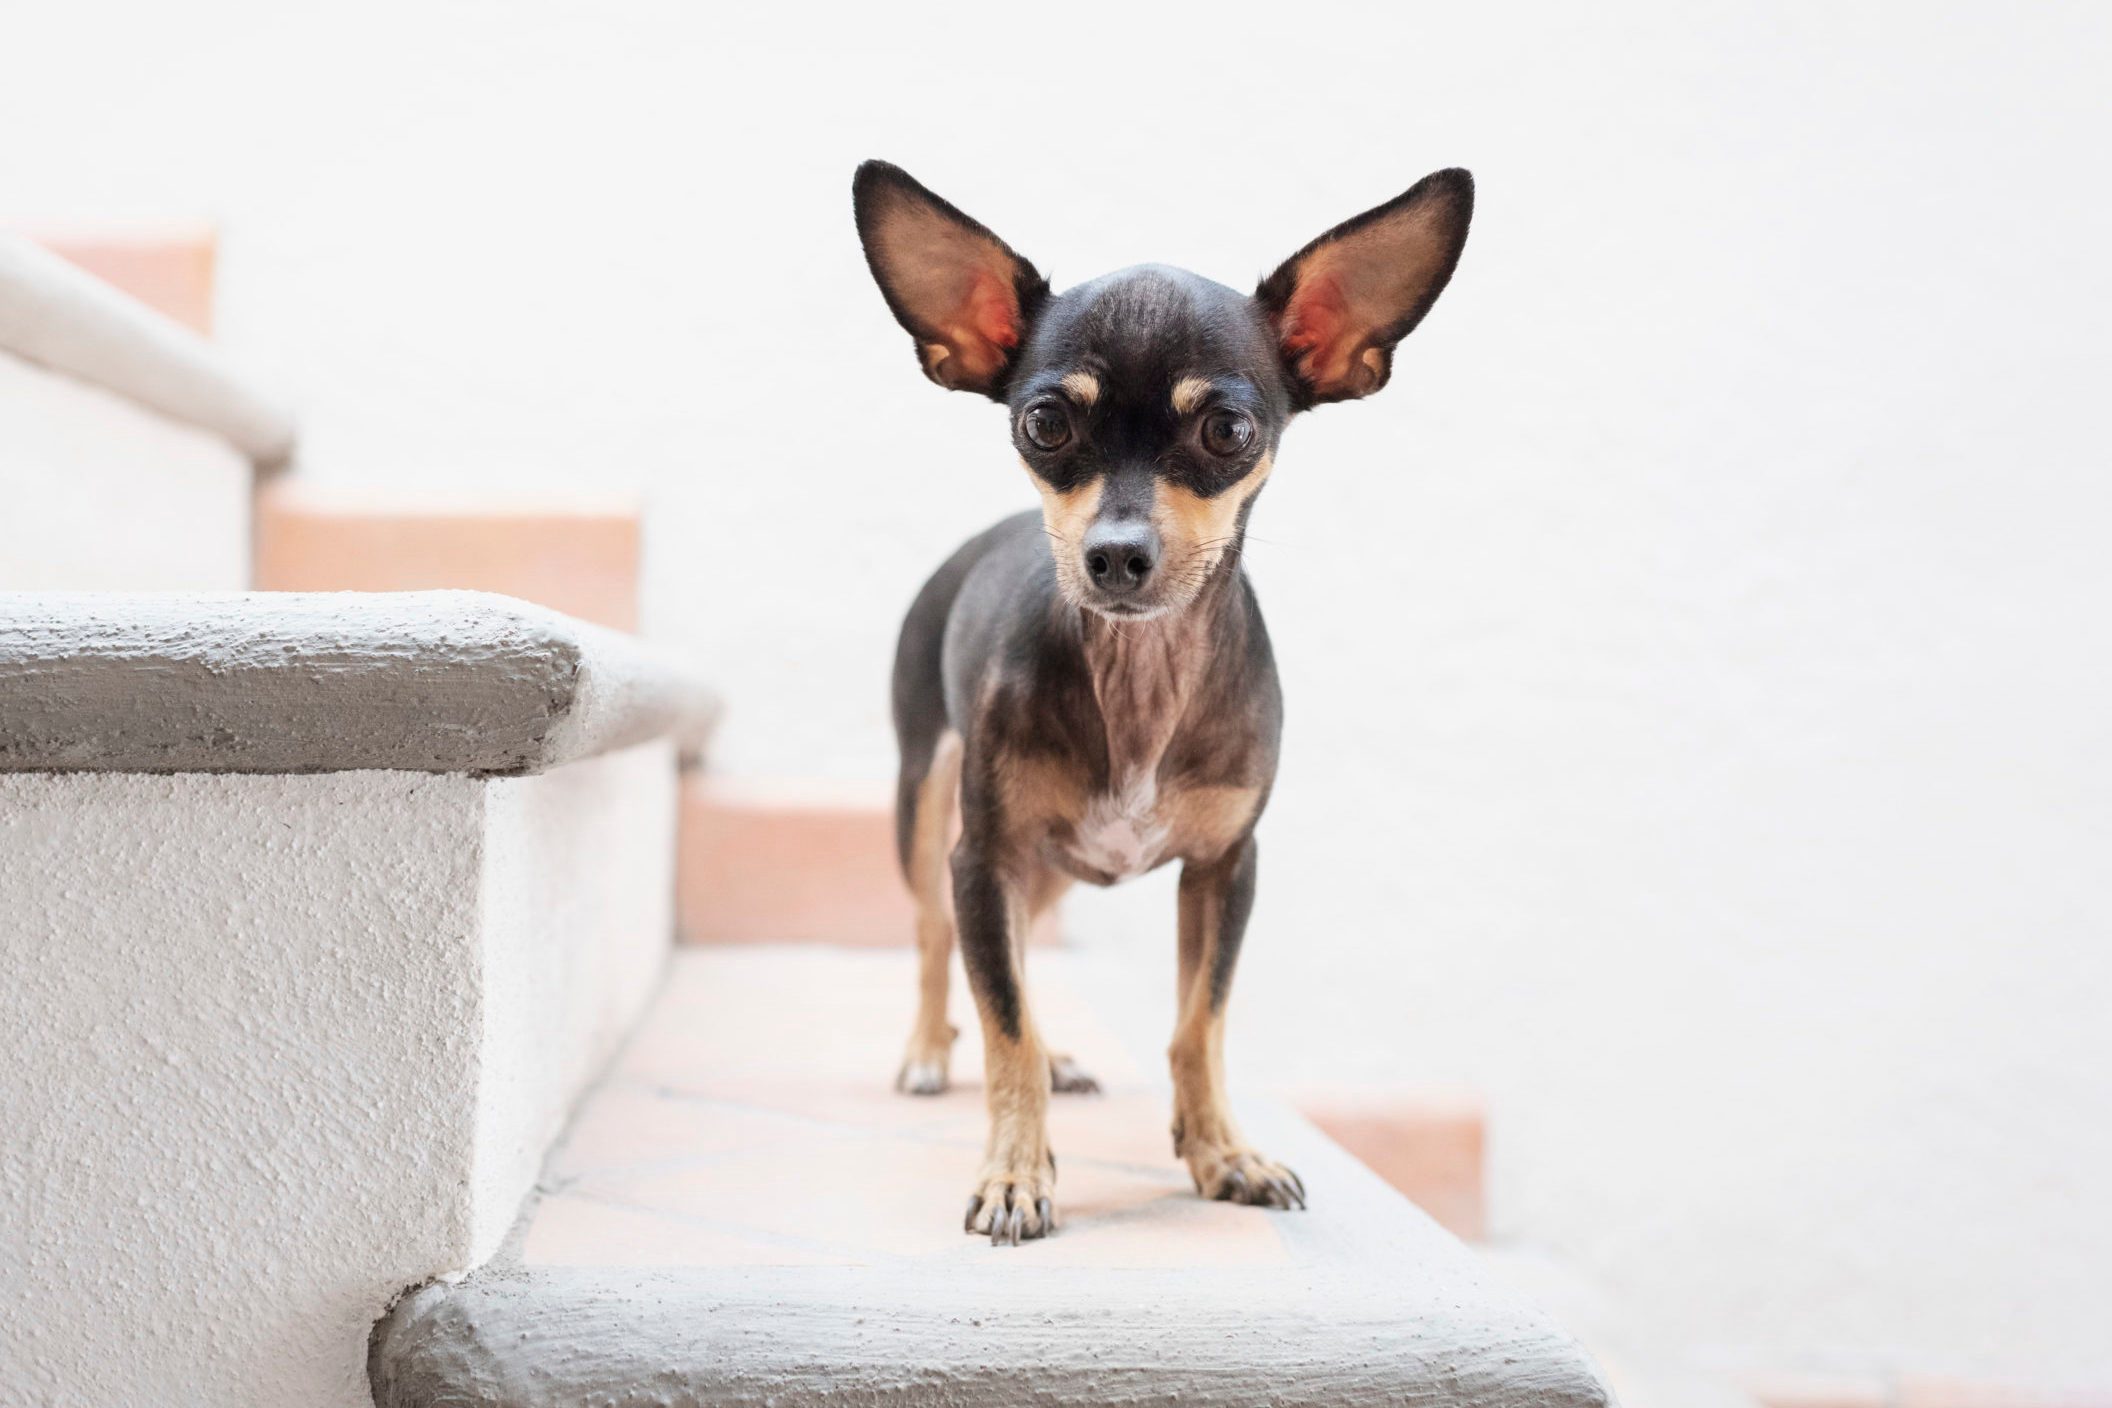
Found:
[851,160,1050,401]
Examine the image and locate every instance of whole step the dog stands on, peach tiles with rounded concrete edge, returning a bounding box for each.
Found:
[372,946,1611,1408]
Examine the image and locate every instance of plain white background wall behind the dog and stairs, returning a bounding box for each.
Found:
[0,0,2112,1376]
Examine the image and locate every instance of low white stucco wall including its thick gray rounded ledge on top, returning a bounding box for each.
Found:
[0,593,710,1408]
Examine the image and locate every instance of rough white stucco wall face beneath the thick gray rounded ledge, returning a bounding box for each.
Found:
[0,745,674,1408]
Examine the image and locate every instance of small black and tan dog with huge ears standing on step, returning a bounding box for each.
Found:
[853,160,1474,1243]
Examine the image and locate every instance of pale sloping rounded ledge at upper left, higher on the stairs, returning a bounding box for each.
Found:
[0,234,294,469]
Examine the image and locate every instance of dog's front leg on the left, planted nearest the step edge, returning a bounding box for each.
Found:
[953,836,1056,1245]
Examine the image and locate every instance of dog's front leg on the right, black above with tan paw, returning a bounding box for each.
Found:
[1166,836,1305,1207]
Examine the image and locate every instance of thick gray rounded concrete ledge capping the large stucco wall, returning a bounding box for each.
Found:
[0,591,714,775]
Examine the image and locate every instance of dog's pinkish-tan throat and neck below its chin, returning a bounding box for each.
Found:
[1079,562,1238,789]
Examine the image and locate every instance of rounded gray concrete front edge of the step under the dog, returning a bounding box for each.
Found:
[367,1267,1614,1408]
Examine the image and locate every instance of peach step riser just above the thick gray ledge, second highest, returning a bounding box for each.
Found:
[256,486,640,631]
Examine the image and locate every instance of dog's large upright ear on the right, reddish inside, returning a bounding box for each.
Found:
[1255,169,1474,407]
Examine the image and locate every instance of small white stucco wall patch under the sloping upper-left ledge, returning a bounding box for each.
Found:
[0,350,251,591]
